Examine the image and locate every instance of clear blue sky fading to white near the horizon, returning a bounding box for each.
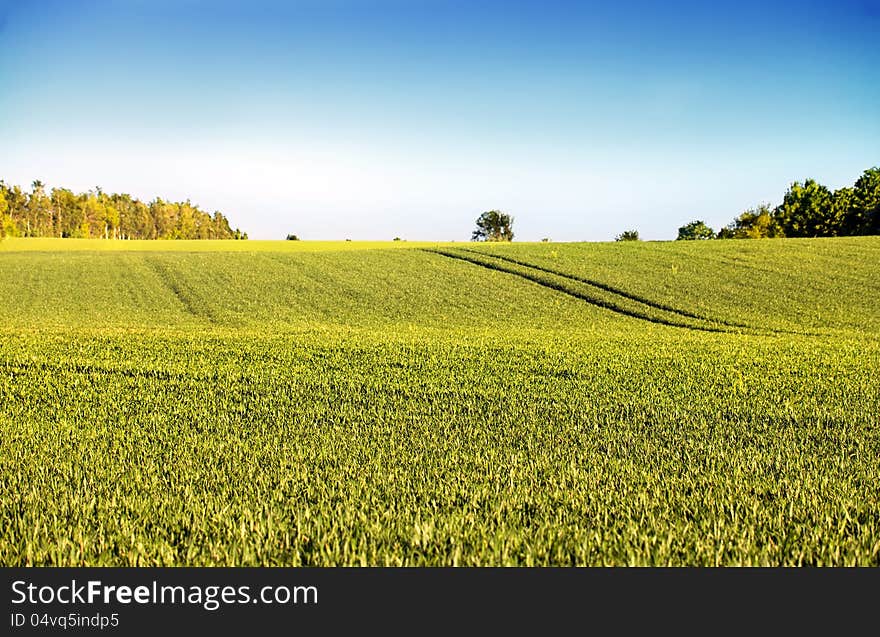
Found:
[0,0,880,241]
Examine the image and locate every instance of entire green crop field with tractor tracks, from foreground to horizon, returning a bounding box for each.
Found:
[0,237,880,566]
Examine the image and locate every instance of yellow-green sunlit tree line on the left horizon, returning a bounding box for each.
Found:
[0,180,247,239]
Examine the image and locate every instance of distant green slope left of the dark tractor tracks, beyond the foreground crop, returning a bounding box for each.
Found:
[0,246,612,333]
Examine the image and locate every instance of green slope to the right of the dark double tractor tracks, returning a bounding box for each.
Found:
[464,237,880,333]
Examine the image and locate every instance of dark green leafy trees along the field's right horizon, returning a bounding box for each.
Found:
[678,167,880,240]
